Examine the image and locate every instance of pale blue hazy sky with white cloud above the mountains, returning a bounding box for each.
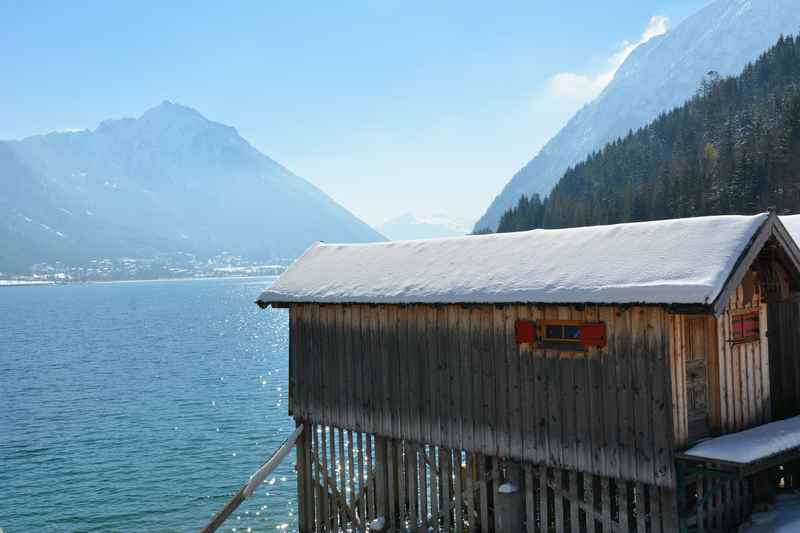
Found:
[0,0,708,224]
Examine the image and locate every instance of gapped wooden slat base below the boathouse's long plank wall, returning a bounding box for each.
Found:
[297,419,677,533]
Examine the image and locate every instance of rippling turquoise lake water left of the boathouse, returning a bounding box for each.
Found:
[0,279,296,533]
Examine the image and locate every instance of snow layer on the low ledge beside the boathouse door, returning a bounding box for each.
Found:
[684,416,800,464]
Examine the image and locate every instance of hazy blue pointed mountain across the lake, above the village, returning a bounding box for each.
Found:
[0,102,384,273]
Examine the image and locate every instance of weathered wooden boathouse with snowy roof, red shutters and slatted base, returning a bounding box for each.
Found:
[258,214,800,533]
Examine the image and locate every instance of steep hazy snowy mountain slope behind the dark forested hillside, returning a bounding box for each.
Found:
[475,0,800,231]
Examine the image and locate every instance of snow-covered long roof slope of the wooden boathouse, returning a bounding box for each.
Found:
[259,214,768,305]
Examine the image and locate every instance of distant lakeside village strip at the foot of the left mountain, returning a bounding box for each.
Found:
[0,252,291,286]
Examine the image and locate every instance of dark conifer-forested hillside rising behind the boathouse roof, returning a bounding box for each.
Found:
[498,37,800,231]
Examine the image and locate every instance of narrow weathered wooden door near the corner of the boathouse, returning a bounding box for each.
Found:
[684,316,711,442]
